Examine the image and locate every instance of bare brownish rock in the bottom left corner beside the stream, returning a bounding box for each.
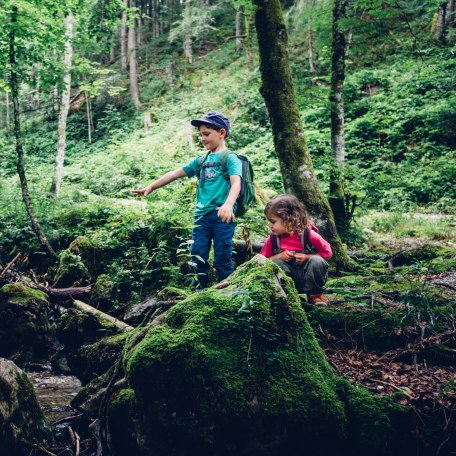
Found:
[0,358,52,456]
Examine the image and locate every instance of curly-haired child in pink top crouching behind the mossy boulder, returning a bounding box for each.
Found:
[260,195,332,305]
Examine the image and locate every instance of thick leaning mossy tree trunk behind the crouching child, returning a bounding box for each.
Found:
[254,0,349,269]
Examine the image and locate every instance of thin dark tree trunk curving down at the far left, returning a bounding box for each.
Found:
[9,6,56,258]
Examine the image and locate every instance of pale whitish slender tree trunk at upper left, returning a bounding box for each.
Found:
[51,11,73,198]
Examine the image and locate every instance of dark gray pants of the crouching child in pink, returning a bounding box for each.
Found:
[273,255,328,294]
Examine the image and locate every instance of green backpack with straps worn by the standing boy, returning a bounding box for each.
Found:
[196,150,256,217]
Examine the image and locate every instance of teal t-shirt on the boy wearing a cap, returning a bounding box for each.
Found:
[182,149,242,217]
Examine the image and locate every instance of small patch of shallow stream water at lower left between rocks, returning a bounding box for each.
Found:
[27,364,82,424]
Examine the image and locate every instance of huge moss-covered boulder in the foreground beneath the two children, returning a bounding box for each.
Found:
[111,256,414,455]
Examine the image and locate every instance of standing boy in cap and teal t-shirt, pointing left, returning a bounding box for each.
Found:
[133,112,242,291]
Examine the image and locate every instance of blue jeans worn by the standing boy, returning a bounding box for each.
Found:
[190,211,234,288]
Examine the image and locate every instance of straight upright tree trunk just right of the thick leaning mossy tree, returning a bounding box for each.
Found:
[329,0,348,231]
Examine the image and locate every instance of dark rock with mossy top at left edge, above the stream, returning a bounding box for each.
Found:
[0,284,54,362]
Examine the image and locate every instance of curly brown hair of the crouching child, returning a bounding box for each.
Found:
[264,195,309,233]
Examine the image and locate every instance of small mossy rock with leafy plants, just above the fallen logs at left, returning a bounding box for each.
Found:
[53,236,96,288]
